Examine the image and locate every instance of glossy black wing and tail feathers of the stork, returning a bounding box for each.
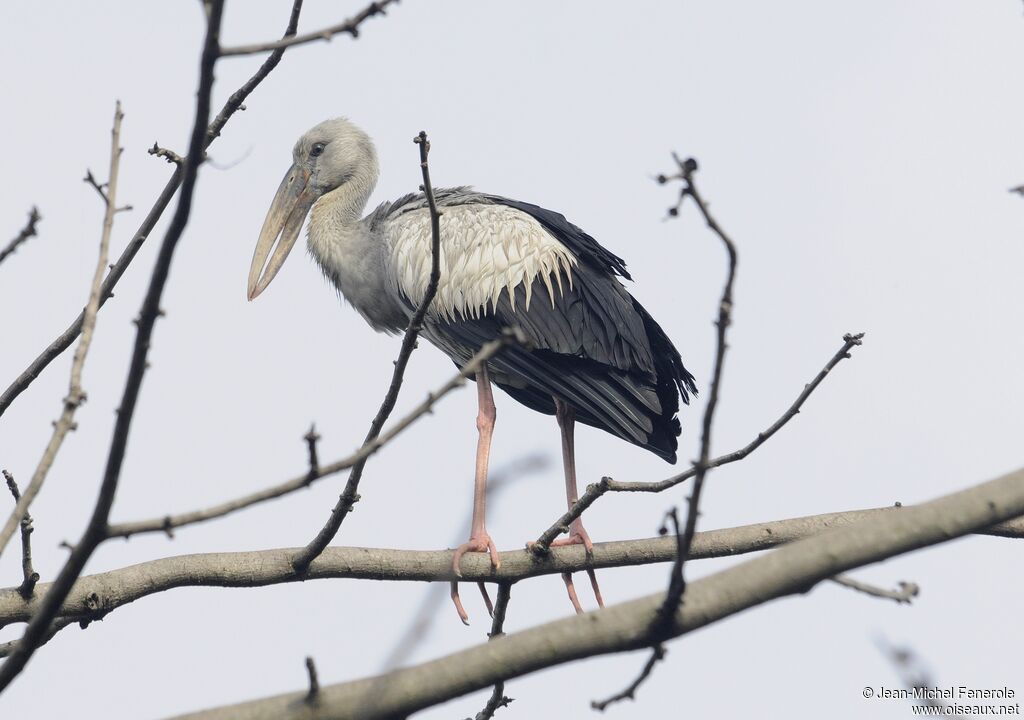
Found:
[428,196,696,463]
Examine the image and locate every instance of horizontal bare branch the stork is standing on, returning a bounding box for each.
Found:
[0,506,1024,626]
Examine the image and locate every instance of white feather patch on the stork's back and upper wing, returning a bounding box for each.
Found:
[386,204,577,322]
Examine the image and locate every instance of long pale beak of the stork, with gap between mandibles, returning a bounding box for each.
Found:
[249,165,318,300]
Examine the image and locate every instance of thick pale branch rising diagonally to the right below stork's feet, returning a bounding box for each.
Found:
[159,470,1024,720]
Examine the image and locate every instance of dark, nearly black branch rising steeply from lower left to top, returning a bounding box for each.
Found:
[0,5,223,691]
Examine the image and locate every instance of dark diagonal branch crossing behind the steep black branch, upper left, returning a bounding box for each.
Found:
[0,0,302,416]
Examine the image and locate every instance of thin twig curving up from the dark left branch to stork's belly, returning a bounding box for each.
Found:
[108,337,512,538]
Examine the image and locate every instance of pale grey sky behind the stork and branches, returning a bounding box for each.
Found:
[0,0,1024,720]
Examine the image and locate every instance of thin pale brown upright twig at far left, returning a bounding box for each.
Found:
[0,100,124,554]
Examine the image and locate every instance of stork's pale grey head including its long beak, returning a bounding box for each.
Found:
[249,118,377,300]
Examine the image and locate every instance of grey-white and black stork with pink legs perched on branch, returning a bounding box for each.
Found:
[248,118,697,624]
